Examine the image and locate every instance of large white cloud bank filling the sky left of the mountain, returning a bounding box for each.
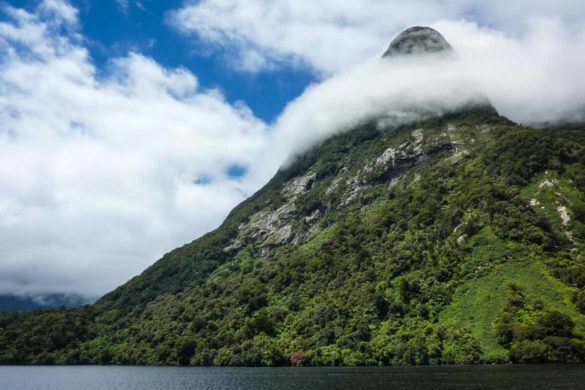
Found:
[0,0,266,296]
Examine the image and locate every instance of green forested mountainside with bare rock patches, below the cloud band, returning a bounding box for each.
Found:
[0,27,585,365]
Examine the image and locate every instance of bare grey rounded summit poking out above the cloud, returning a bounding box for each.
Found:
[382,27,453,57]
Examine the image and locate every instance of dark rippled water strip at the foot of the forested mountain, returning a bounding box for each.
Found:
[0,365,585,390]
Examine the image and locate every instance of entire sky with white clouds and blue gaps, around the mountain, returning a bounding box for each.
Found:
[0,0,585,299]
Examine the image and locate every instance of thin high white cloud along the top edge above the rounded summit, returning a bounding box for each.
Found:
[169,0,585,76]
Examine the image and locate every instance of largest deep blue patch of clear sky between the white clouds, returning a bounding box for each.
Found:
[52,0,316,122]
